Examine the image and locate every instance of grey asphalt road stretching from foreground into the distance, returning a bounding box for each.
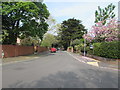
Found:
[2,51,118,88]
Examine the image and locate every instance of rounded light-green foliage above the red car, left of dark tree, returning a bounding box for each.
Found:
[41,33,57,47]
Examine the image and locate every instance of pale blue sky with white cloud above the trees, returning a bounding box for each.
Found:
[44,0,118,34]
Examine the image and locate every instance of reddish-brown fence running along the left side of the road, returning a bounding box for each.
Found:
[0,45,47,58]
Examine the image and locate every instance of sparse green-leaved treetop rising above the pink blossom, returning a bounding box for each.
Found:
[95,3,115,25]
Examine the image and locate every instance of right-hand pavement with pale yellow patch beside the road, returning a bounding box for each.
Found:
[67,52,119,70]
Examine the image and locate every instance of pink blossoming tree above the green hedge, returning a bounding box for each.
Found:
[83,18,119,42]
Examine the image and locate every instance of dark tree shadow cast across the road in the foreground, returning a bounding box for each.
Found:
[9,70,118,88]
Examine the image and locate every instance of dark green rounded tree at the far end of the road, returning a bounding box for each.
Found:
[58,18,86,49]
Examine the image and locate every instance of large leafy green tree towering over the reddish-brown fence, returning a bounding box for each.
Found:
[2,2,49,44]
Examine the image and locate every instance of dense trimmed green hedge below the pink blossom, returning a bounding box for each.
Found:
[87,41,120,59]
